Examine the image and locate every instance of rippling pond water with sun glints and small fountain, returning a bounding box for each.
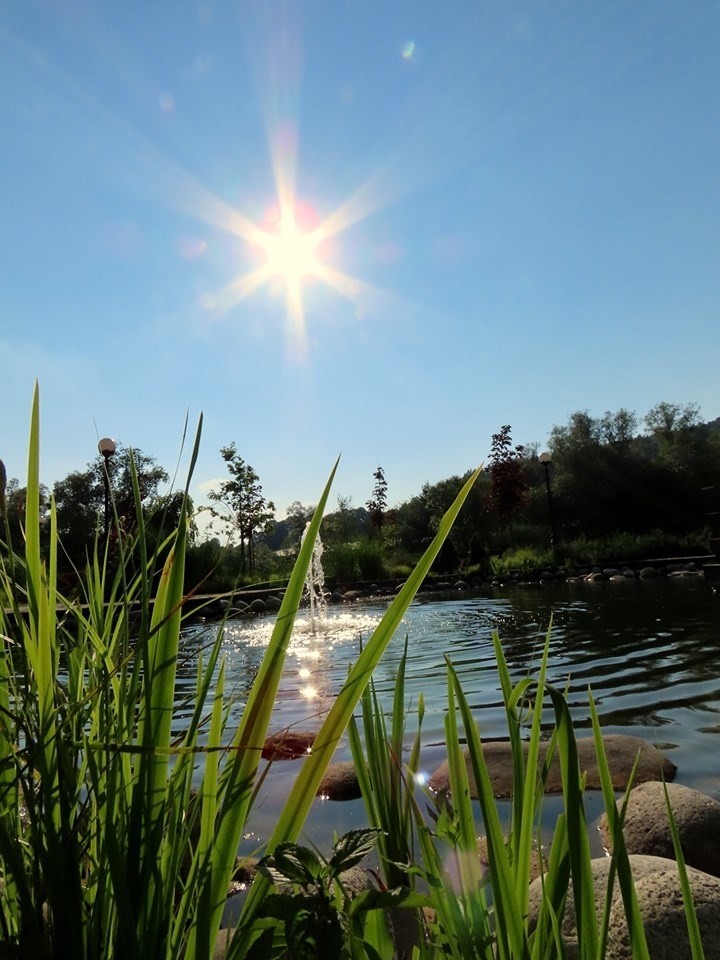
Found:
[178,578,720,853]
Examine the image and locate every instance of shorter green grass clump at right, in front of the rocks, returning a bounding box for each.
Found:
[351,631,703,960]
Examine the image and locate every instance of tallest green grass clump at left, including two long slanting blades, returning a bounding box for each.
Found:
[0,389,484,960]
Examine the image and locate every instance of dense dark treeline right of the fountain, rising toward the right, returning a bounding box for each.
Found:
[258,403,720,579]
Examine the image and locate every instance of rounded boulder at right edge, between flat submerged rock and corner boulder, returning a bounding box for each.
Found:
[600,783,720,877]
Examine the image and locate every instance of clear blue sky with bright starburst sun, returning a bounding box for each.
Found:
[0,0,720,515]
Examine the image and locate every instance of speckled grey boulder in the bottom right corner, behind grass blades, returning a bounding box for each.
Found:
[529,855,720,960]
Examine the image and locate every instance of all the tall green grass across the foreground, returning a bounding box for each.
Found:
[0,391,702,960]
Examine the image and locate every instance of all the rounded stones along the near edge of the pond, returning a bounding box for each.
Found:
[256,731,720,960]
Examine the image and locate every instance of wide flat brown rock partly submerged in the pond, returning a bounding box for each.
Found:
[429,733,677,799]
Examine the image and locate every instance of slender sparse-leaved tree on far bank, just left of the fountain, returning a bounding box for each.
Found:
[208,442,275,574]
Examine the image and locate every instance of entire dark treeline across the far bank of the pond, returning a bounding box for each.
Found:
[0,403,720,592]
